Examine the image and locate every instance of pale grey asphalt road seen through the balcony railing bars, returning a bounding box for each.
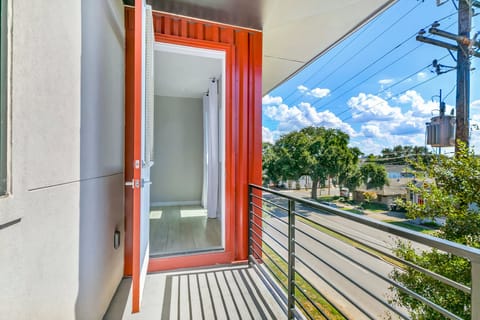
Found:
[256,192,406,319]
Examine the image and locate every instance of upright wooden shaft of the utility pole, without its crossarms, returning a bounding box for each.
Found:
[455,0,472,153]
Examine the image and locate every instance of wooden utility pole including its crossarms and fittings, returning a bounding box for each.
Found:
[416,0,480,153]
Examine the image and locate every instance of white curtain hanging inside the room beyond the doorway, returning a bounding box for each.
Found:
[202,79,219,218]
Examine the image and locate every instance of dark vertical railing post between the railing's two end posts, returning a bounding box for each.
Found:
[287,199,295,319]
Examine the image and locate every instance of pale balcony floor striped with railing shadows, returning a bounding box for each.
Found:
[104,265,285,320]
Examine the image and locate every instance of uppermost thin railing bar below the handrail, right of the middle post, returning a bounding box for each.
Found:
[295,214,472,294]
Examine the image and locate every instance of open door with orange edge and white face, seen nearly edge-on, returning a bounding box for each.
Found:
[125,0,153,312]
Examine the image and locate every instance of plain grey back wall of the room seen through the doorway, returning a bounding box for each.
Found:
[150,96,203,205]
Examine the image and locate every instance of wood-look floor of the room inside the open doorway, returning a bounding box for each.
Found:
[150,206,222,256]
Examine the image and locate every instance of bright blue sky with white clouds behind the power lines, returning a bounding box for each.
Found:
[262,0,480,155]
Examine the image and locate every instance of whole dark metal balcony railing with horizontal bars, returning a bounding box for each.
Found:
[248,184,480,320]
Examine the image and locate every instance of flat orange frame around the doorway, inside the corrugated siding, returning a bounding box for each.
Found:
[148,34,236,272]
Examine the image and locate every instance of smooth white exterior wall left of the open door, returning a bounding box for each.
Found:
[0,0,124,319]
